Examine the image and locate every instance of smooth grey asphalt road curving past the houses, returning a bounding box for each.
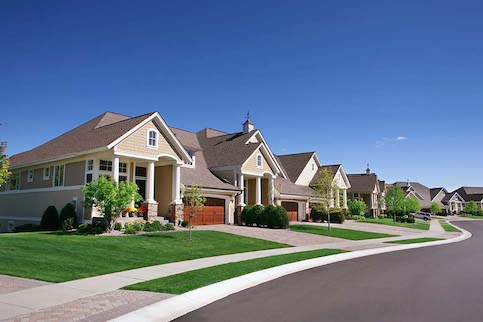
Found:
[177,220,483,322]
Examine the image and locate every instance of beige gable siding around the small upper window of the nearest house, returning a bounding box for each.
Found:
[116,121,180,160]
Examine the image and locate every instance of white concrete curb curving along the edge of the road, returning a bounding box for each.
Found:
[111,223,471,322]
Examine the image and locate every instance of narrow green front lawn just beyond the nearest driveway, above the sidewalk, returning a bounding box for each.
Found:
[290,225,395,240]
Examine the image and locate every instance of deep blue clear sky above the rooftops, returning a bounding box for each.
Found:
[0,0,483,189]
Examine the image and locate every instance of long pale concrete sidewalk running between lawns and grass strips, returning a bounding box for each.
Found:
[0,223,458,320]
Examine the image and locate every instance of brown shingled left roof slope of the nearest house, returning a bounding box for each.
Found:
[10,112,153,168]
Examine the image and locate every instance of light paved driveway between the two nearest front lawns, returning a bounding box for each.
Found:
[196,225,346,246]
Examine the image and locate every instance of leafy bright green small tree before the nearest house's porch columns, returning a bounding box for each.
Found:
[82,176,142,232]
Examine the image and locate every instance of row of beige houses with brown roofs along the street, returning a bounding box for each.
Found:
[0,112,483,231]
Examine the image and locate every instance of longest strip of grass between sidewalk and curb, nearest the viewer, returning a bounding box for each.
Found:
[125,249,345,294]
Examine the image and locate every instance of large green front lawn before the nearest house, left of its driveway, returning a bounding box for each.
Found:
[0,231,290,282]
